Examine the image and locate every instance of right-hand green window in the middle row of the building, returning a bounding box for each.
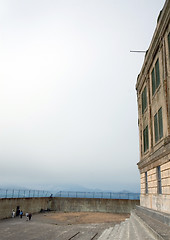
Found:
[154,108,163,143]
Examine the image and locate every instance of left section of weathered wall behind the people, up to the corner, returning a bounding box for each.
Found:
[0,198,52,219]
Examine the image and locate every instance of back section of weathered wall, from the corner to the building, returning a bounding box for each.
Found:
[52,198,139,213]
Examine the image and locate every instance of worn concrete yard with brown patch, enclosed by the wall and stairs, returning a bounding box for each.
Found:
[0,212,130,240]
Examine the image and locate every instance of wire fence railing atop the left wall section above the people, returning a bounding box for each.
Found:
[0,189,51,198]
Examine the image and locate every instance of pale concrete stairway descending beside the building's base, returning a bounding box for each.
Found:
[98,208,170,240]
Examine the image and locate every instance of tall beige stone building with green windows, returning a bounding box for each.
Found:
[136,0,170,213]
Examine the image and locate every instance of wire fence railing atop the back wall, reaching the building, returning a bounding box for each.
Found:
[53,191,140,200]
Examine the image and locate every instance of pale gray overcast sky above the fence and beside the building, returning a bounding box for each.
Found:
[0,0,164,191]
